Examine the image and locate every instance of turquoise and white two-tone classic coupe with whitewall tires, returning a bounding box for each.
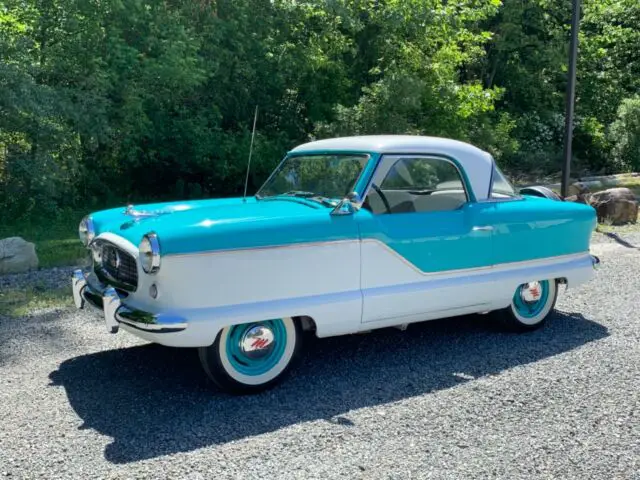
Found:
[72,135,599,393]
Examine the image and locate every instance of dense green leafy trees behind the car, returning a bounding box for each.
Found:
[0,0,640,217]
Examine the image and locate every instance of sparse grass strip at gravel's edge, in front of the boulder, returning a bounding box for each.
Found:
[0,286,73,317]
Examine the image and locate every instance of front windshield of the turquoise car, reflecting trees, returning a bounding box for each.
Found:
[256,154,369,205]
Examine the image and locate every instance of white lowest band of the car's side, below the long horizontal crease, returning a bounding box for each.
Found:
[116,254,594,347]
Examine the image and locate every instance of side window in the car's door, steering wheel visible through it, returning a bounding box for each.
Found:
[368,157,467,214]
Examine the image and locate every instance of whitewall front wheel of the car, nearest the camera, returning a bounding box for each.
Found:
[198,318,302,394]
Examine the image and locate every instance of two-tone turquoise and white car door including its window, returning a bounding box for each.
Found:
[359,155,495,323]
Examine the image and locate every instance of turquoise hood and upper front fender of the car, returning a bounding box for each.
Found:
[91,197,351,255]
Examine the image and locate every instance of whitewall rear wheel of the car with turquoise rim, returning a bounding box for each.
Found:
[497,279,558,331]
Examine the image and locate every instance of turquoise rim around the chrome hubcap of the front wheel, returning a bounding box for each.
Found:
[226,319,287,377]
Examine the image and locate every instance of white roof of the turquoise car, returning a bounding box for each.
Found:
[290,135,493,200]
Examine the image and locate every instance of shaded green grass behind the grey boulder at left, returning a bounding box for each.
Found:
[0,212,87,268]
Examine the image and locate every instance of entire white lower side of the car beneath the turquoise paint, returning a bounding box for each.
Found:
[79,233,594,347]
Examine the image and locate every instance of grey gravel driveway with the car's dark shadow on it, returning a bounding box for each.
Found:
[0,235,640,480]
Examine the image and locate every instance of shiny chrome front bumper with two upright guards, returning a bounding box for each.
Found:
[71,269,187,333]
